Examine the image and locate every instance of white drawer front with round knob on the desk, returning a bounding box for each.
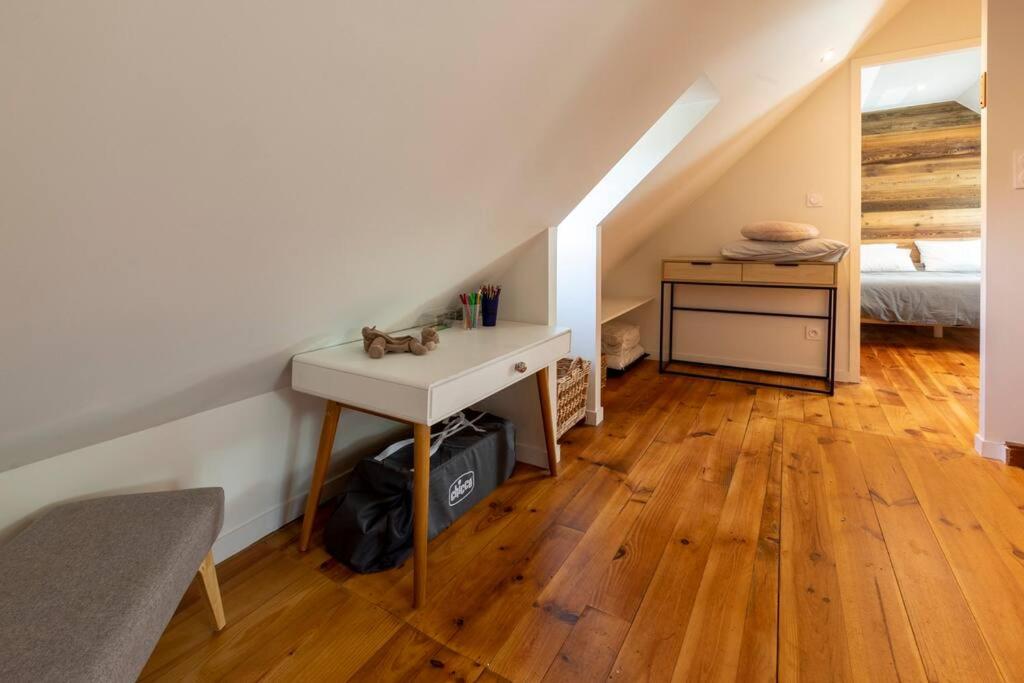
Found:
[430,333,569,424]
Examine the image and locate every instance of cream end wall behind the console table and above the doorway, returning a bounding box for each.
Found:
[603,0,981,380]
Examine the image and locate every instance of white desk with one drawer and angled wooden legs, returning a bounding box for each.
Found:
[292,322,569,606]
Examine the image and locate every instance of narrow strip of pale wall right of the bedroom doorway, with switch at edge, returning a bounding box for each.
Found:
[978,0,1024,459]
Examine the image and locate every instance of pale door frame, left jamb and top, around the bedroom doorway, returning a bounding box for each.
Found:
[850,38,985,382]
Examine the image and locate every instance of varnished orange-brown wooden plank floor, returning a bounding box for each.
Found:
[144,330,1024,681]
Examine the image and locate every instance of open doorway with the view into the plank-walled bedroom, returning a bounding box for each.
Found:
[851,43,982,425]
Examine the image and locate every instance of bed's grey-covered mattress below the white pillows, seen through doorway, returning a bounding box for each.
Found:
[860,270,981,336]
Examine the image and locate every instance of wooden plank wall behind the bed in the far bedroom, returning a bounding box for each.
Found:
[861,102,981,261]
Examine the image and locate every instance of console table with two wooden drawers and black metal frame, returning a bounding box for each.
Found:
[658,257,839,396]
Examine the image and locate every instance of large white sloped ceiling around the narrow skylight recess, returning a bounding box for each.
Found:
[0,0,905,470]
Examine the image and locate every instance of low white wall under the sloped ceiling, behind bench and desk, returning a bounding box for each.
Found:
[0,389,403,560]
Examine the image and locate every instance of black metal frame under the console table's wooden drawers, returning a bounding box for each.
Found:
[657,280,838,396]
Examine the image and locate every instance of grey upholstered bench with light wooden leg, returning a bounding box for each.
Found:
[0,488,224,683]
